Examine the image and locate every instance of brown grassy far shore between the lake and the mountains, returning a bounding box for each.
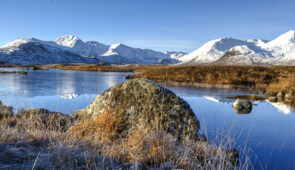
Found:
[0,63,295,107]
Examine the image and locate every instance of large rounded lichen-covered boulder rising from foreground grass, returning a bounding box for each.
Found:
[73,79,200,139]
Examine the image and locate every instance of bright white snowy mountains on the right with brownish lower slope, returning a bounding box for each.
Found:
[180,30,295,65]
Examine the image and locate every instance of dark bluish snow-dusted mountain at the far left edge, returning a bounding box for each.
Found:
[0,38,97,65]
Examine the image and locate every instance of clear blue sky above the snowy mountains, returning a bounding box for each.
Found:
[0,0,295,52]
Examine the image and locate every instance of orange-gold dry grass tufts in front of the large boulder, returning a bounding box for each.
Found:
[70,113,248,169]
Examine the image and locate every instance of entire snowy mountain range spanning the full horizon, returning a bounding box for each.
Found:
[0,30,295,65]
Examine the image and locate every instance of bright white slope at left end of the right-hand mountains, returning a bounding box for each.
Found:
[180,38,249,64]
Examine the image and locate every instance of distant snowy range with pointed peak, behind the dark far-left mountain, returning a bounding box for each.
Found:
[55,35,183,64]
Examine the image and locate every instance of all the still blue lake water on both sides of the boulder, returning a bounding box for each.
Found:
[0,68,295,169]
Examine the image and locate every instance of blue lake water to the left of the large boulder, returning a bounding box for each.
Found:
[0,68,130,113]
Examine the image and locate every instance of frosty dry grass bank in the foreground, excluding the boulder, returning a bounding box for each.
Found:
[0,102,250,169]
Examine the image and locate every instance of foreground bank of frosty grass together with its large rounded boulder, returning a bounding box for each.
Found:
[0,79,239,169]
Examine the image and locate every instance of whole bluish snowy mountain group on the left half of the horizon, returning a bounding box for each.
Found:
[0,35,185,64]
